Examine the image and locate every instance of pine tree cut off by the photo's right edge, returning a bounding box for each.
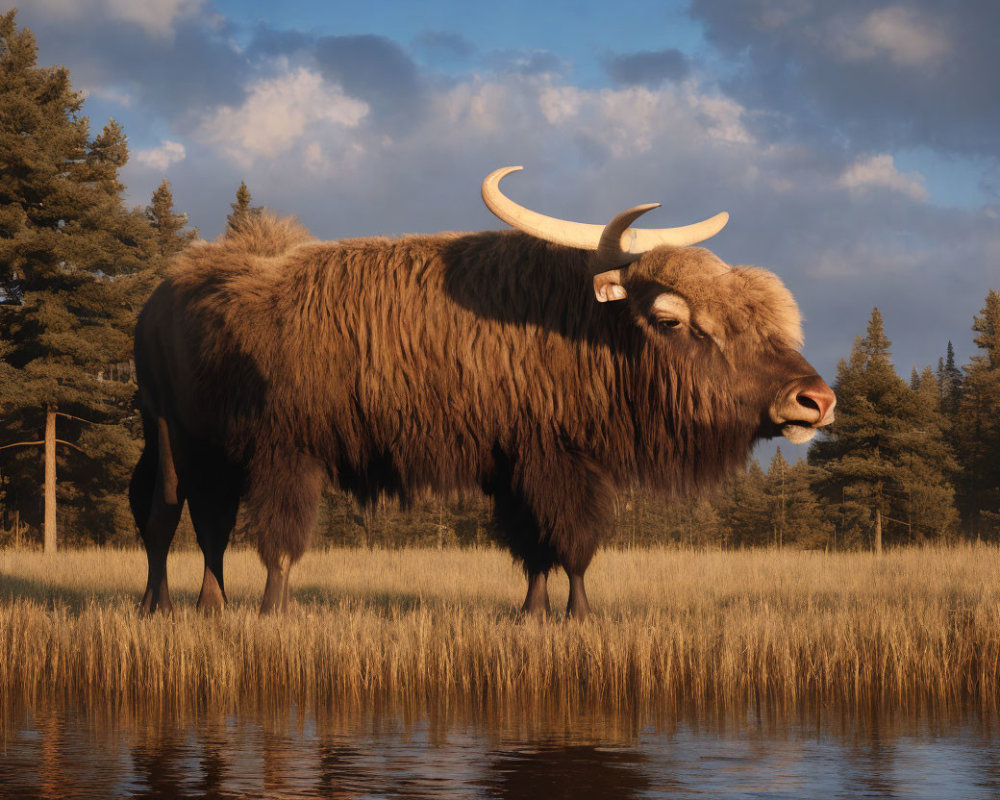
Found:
[953,289,1000,540]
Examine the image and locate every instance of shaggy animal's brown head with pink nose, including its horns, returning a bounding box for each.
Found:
[483,167,836,443]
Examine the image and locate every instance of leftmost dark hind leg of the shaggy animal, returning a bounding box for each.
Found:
[129,418,184,614]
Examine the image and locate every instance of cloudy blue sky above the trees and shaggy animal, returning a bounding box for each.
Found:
[7,0,1000,457]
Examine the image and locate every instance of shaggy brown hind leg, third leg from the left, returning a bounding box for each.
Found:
[246,453,326,614]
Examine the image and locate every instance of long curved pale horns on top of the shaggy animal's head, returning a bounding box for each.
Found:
[482,167,729,264]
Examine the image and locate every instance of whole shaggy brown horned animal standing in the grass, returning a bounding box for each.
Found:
[130,168,835,617]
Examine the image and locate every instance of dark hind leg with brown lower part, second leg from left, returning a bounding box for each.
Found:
[186,452,242,611]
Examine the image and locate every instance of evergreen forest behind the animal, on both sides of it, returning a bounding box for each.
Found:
[0,12,1000,550]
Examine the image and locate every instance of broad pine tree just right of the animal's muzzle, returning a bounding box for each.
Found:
[809,308,956,550]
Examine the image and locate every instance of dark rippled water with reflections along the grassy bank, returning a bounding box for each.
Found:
[0,709,1000,800]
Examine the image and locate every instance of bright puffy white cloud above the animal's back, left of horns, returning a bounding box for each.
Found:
[197,68,368,167]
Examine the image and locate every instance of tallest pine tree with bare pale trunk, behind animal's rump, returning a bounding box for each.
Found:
[0,12,162,549]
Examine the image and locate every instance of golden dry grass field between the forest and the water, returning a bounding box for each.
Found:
[0,547,1000,711]
